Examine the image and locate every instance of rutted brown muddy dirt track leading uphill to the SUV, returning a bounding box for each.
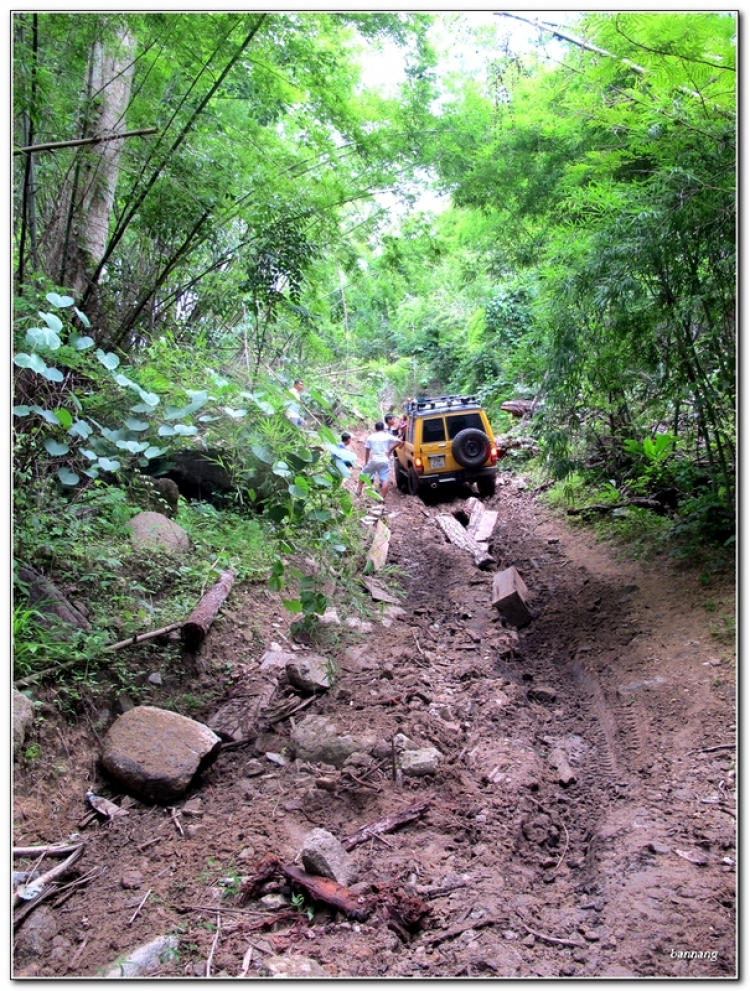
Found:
[13,474,736,978]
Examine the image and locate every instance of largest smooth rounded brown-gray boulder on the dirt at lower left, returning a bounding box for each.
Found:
[102,705,221,804]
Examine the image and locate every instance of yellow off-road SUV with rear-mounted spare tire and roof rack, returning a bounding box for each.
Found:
[395,396,497,496]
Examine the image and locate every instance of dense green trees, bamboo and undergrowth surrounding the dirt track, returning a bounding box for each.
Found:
[13,12,737,688]
